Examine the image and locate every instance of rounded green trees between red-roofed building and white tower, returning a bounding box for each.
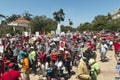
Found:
[30,16,57,33]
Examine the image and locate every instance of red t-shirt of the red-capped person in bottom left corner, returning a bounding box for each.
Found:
[0,70,21,80]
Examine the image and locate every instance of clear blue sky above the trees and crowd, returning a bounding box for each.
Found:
[0,0,120,27]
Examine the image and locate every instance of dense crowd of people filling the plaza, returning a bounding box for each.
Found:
[0,31,120,80]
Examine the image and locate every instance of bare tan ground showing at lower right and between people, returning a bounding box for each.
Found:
[26,50,118,80]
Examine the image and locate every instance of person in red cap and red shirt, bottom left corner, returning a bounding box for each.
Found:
[0,63,22,80]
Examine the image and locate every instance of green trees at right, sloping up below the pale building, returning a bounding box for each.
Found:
[77,13,120,32]
